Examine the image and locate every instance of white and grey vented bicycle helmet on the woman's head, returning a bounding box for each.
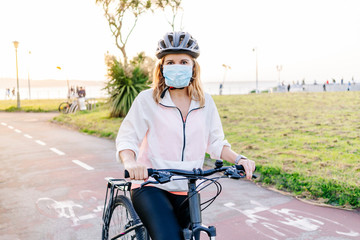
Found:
[156,32,200,59]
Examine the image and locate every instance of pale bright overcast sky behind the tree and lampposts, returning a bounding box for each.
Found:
[0,0,360,83]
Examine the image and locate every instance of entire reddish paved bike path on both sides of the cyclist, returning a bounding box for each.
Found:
[0,112,360,240]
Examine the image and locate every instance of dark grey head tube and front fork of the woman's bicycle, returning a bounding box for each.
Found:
[183,179,216,240]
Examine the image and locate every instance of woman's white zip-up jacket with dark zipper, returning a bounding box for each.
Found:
[116,89,230,191]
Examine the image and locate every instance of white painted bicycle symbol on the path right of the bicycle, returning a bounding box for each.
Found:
[224,200,360,240]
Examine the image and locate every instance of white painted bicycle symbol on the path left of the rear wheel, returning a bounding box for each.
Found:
[36,190,103,227]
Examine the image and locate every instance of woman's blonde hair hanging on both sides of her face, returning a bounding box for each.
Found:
[152,56,205,107]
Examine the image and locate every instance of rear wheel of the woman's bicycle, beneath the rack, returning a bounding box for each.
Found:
[102,195,149,240]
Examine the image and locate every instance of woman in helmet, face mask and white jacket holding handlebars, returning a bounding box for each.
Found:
[116,32,255,240]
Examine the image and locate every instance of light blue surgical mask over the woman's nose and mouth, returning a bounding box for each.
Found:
[163,64,192,88]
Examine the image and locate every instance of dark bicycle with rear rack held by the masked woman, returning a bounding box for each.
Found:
[102,160,256,240]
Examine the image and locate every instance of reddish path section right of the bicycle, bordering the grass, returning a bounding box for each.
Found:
[203,179,360,240]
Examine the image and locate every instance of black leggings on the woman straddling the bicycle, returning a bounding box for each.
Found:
[131,186,190,240]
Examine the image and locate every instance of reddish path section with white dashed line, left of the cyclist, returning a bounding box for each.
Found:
[0,113,123,240]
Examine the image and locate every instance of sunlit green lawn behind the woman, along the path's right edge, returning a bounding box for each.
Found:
[0,92,360,208]
